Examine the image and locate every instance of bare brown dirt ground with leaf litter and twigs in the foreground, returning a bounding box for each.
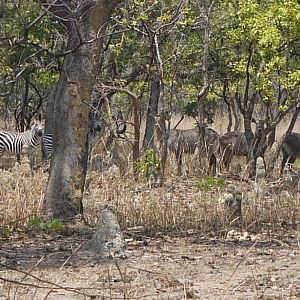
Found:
[0,229,300,300]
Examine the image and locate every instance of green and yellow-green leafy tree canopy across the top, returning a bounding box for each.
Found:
[0,0,300,122]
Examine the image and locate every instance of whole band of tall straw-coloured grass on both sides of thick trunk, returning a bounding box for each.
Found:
[0,113,300,234]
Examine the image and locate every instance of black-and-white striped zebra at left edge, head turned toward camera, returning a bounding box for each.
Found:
[0,120,44,172]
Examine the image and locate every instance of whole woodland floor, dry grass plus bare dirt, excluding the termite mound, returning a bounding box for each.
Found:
[0,154,300,299]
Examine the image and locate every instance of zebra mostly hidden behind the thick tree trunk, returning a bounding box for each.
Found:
[42,113,103,160]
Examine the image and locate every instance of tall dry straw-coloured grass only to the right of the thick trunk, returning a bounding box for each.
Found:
[85,166,300,234]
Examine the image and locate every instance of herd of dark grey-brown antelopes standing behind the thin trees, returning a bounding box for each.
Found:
[168,126,300,176]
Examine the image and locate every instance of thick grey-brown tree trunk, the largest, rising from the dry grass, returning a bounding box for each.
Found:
[44,0,118,219]
